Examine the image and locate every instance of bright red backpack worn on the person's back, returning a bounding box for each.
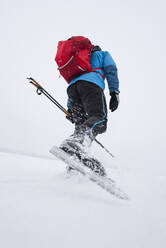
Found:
[55,36,103,83]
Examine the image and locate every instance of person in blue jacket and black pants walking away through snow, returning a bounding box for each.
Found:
[60,43,119,158]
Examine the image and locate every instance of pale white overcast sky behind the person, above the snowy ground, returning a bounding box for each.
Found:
[0,0,166,170]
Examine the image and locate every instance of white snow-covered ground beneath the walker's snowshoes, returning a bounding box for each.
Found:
[0,152,166,248]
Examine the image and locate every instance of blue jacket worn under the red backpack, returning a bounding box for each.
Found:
[68,51,119,108]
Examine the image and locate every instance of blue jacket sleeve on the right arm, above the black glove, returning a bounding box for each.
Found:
[103,52,119,93]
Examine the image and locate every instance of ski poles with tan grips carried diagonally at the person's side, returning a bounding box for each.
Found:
[27,77,114,157]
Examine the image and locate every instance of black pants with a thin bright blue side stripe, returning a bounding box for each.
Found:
[67,81,107,136]
